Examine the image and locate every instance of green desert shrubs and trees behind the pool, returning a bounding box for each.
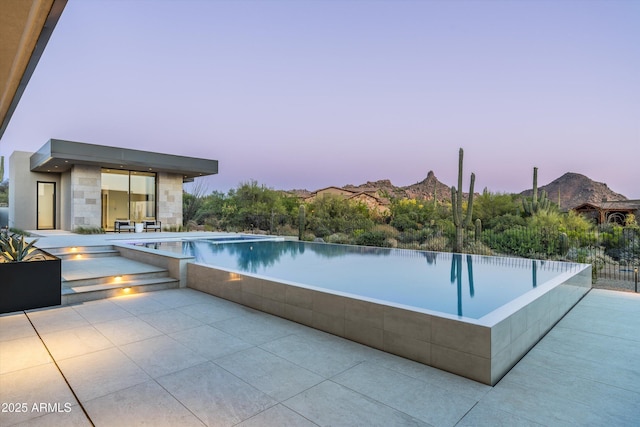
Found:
[184,177,640,284]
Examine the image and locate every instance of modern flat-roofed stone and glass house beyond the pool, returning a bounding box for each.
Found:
[9,139,218,231]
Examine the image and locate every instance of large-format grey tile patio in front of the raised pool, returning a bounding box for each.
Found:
[0,289,640,427]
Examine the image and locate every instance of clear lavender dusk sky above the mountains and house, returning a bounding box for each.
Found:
[0,0,640,199]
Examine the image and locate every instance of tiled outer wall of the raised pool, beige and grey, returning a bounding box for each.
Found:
[187,263,591,385]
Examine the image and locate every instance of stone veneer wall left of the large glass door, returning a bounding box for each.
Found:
[69,165,102,231]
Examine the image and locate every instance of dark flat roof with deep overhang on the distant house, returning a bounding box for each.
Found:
[30,139,218,182]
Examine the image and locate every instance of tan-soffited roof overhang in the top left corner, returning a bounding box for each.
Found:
[0,0,67,144]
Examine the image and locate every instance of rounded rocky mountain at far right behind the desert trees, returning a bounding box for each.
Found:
[520,172,627,210]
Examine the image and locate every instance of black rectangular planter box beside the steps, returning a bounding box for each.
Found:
[0,251,62,313]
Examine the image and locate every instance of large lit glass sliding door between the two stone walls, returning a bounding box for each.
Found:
[102,169,156,230]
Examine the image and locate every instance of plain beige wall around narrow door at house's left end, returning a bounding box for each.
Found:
[9,151,61,230]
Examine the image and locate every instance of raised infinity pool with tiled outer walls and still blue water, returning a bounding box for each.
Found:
[132,239,591,385]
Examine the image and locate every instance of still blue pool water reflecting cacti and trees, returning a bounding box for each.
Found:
[141,240,580,319]
